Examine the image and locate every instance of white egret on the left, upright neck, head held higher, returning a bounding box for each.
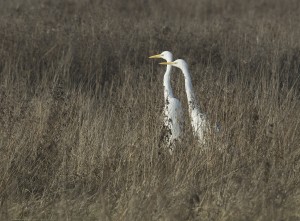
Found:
[149,51,183,153]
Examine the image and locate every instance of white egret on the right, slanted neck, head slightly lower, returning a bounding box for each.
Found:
[160,59,209,144]
